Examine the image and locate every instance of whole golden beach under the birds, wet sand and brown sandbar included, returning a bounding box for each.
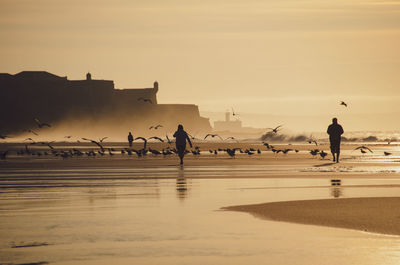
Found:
[0,142,400,265]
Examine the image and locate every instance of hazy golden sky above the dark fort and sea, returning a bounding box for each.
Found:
[0,0,400,129]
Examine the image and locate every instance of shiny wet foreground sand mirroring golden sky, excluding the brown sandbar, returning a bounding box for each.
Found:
[0,166,400,265]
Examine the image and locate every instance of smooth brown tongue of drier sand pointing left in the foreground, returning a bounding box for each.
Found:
[223,197,400,235]
